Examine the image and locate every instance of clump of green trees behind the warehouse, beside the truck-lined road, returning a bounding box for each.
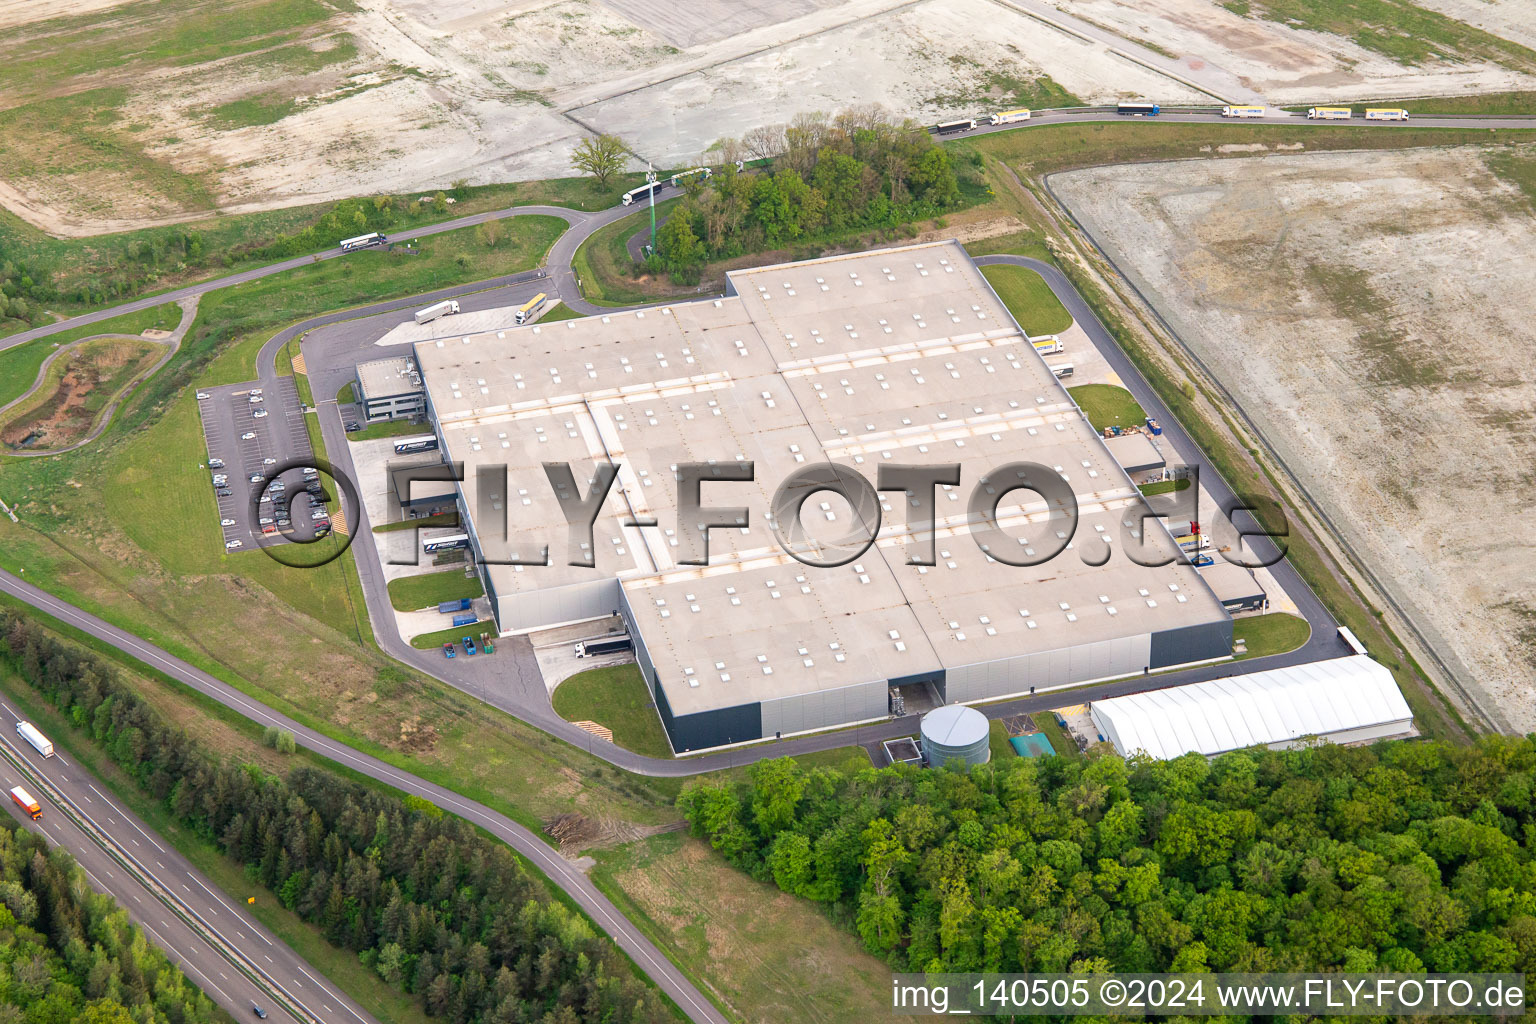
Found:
[647,106,960,278]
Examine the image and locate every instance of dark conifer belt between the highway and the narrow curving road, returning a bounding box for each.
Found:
[0,614,671,1024]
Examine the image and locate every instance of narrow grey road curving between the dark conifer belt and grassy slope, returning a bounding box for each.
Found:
[0,571,727,1024]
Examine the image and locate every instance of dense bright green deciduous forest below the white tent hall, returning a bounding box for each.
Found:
[679,737,1536,972]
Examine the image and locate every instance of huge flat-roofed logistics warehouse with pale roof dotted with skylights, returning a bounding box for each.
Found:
[416,243,1232,752]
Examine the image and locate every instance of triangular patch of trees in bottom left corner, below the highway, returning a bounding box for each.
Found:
[0,820,229,1024]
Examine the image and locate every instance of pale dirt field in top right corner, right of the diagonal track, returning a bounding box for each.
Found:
[1057,0,1536,103]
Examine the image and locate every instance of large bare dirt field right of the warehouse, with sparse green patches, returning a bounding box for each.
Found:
[1051,147,1536,732]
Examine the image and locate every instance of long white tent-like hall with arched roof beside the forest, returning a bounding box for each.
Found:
[1089,654,1415,760]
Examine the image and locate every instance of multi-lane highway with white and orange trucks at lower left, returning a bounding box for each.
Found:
[0,699,378,1024]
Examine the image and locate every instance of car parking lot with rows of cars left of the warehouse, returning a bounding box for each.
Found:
[198,378,335,551]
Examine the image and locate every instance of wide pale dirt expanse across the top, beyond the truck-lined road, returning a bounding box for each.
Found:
[27,0,1536,236]
